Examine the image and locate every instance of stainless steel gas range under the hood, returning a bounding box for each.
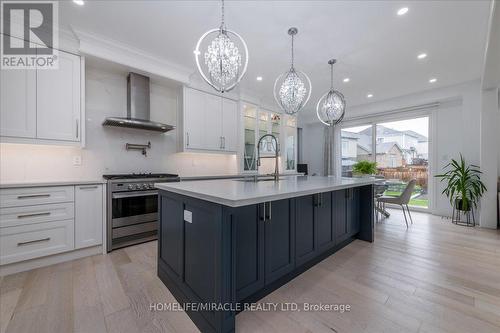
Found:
[103,173,180,252]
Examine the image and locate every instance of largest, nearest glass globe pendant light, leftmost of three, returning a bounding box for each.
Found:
[194,0,248,93]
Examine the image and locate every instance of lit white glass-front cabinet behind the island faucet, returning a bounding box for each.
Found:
[240,102,297,173]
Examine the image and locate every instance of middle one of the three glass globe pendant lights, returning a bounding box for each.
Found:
[273,28,312,115]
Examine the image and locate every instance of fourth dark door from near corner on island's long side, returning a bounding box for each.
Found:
[314,192,335,252]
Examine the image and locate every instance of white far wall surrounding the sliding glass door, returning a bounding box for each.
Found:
[299,81,481,216]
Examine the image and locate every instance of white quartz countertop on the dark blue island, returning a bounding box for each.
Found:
[155,176,377,207]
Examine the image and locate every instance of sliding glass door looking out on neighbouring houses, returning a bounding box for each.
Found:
[341,116,429,208]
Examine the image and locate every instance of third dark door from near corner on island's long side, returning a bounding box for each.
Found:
[295,194,314,266]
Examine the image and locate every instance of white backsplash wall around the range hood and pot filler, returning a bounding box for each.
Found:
[0,67,238,182]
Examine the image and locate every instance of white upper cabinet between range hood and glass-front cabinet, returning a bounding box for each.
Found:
[182,88,238,153]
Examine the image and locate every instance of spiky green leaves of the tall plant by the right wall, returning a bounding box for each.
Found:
[436,154,486,212]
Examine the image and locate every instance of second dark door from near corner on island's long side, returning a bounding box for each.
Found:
[265,199,295,284]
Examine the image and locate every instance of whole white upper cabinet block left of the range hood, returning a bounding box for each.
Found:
[0,37,84,144]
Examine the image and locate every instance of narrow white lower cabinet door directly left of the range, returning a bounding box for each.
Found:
[75,185,103,249]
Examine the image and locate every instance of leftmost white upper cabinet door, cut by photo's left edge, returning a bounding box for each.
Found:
[0,69,36,138]
